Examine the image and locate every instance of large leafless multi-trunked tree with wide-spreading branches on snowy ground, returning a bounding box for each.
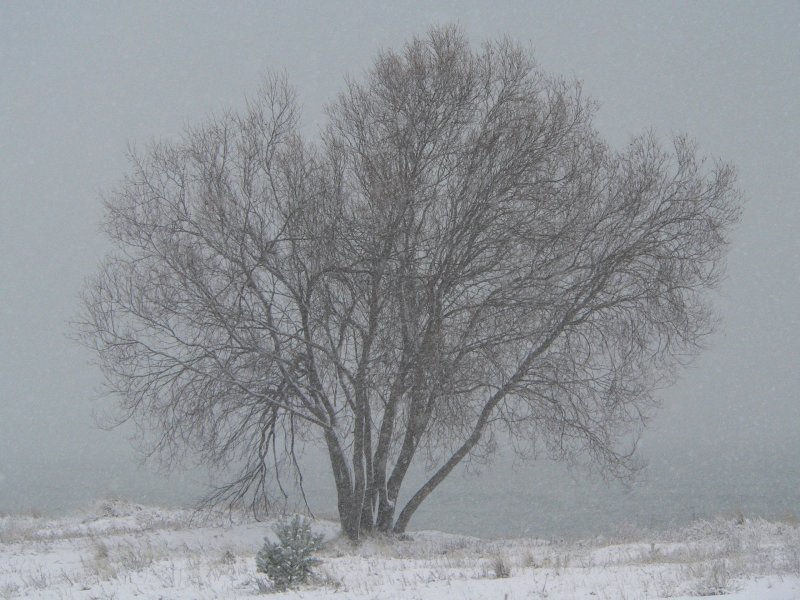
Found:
[82,28,739,539]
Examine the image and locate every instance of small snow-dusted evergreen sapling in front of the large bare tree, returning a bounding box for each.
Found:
[256,515,323,590]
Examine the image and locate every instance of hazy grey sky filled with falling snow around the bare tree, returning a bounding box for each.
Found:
[0,1,800,524]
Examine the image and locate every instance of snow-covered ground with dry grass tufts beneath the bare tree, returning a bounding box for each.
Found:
[0,501,800,600]
